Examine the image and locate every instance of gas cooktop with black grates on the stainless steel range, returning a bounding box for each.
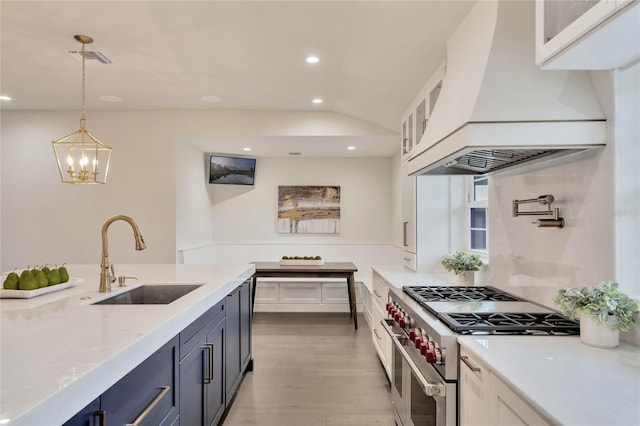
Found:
[402,286,580,335]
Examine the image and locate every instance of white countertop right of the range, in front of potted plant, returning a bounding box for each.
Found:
[458,336,640,426]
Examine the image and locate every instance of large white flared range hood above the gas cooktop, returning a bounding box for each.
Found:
[409,0,606,175]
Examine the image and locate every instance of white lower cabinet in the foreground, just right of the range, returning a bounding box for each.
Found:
[458,346,550,426]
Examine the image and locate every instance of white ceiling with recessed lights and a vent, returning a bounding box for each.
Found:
[0,0,473,155]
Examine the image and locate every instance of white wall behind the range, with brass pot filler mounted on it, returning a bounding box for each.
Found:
[488,65,640,344]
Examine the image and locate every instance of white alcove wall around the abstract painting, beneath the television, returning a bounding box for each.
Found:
[177,145,394,281]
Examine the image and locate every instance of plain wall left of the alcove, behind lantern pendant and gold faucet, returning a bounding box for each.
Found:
[1,111,176,270]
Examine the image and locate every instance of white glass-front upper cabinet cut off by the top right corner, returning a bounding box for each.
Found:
[536,0,640,70]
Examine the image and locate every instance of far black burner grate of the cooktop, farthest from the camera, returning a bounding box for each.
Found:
[402,286,521,303]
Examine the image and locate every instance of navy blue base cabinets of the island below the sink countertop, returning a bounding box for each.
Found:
[64,280,253,426]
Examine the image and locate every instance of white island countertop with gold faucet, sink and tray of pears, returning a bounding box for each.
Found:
[0,264,255,426]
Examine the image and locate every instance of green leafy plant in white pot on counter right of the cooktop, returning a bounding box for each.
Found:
[553,281,640,348]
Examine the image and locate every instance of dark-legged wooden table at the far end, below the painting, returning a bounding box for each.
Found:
[251,262,358,330]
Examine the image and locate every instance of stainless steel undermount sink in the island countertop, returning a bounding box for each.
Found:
[93,284,202,305]
